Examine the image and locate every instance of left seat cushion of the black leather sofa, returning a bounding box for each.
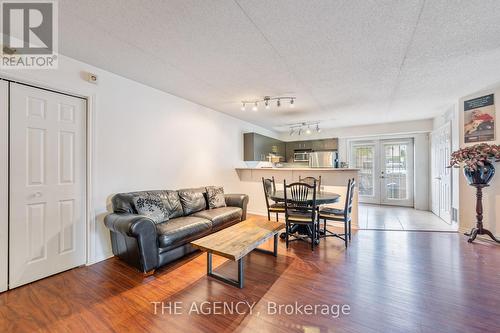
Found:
[156,216,212,248]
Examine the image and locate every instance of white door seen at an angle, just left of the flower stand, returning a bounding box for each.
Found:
[431,124,451,223]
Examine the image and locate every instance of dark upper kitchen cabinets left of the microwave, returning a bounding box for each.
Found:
[243,133,286,161]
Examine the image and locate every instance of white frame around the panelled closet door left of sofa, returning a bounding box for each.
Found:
[0,73,97,280]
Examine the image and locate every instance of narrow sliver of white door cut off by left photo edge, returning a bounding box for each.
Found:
[0,80,9,292]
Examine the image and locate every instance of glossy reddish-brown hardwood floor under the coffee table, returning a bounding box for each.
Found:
[0,217,500,333]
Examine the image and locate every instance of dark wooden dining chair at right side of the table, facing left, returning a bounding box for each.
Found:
[318,178,356,248]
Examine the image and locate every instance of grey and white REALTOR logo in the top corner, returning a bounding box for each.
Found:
[0,0,58,69]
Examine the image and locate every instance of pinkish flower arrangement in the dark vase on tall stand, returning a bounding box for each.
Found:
[450,143,500,171]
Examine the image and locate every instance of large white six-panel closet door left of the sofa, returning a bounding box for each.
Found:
[9,83,86,288]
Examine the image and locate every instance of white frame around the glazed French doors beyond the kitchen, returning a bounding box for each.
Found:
[346,133,417,208]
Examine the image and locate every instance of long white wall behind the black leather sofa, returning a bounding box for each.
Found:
[0,56,276,262]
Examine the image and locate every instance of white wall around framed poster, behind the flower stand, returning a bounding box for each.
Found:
[458,84,500,237]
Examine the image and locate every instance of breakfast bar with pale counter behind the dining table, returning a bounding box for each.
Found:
[236,167,359,228]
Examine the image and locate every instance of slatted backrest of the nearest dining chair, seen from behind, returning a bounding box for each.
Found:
[283,180,316,220]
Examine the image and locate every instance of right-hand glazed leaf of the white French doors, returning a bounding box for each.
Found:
[380,139,414,207]
